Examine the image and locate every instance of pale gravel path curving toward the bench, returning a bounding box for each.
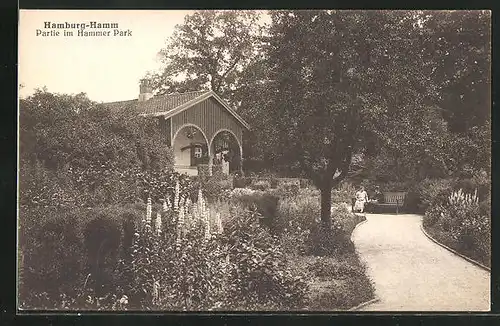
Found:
[352,214,490,311]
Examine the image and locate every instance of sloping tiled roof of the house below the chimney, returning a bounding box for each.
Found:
[104,90,210,115]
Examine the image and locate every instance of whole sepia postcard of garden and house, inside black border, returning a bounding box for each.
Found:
[17,10,491,313]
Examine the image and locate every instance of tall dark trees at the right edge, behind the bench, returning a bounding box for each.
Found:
[362,11,491,180]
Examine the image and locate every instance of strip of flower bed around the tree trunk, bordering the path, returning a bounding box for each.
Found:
[266,189,374,311]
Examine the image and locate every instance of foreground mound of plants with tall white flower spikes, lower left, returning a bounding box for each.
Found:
[20,183,308,311]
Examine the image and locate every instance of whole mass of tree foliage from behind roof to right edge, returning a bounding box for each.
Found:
[143,10,491,229]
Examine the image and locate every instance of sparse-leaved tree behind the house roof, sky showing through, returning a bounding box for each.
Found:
[148,10,262,101]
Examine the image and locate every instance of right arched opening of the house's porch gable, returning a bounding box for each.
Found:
[211,129,242,175]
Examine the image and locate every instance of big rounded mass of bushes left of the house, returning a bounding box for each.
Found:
[19,90,173,206]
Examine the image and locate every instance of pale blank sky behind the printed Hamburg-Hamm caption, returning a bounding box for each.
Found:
[19,10,193,102]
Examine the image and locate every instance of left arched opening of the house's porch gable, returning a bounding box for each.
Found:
[173,124,210,175]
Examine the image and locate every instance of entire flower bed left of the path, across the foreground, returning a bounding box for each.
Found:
[19,175,373,311]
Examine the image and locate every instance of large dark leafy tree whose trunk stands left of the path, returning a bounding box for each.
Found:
[258,11,487,226]
